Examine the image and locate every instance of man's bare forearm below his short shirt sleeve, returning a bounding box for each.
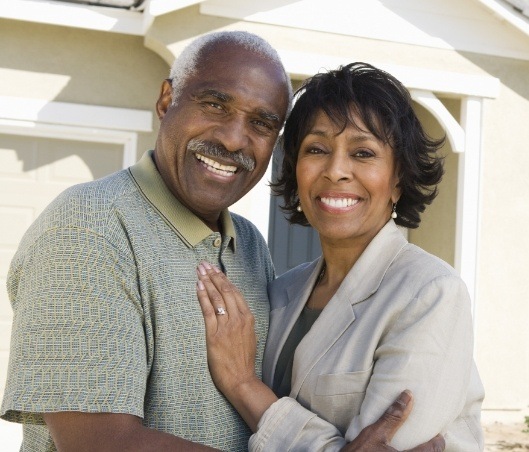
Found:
[43,411,217,452]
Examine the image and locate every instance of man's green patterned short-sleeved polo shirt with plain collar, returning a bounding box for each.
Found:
[0,152,274,451]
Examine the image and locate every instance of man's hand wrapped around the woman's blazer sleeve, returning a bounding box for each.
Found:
[342,390,445,452]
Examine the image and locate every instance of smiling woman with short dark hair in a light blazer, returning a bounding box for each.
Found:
[197,63,483,451]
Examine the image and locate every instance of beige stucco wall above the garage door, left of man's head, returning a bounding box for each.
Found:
[0,19,169,155]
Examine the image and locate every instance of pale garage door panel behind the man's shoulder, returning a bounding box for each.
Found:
[0,134,123,399]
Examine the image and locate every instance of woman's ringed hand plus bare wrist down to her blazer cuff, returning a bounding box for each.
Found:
[197,262,277,432]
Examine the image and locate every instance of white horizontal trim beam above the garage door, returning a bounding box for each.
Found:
[0,96,152,132]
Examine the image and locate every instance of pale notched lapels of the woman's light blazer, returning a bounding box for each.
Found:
[288,220,407,397]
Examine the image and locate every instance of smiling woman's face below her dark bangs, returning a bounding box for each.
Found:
[296,112,400,244]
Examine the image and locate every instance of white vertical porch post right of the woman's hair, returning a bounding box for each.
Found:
[455,97,483,313]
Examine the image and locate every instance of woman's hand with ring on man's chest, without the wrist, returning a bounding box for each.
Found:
[197,262,257,397]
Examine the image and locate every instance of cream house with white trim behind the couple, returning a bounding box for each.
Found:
[0,0,529,444]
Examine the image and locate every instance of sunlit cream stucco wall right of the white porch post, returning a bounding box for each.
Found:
[466,55,529,420]
